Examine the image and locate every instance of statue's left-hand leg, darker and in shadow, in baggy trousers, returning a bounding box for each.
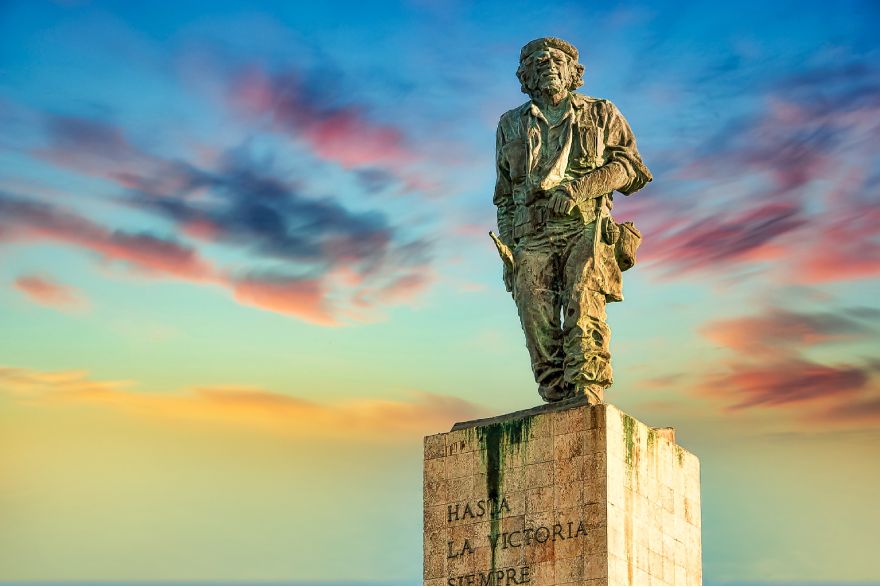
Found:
[513,244,565,402]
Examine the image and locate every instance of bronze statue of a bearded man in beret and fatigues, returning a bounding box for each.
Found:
[493,37,651,403]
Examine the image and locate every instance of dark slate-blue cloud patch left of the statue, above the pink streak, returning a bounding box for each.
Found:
[124,151,430,284]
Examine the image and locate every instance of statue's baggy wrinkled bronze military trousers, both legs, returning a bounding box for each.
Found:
[513,217,612,401]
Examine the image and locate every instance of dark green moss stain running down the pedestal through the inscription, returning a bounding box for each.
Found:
[476,416,532,577]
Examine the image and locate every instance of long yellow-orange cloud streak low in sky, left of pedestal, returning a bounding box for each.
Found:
[0,367,488,440]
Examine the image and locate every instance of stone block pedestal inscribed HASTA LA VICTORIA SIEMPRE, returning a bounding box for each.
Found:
[424,404,702,585]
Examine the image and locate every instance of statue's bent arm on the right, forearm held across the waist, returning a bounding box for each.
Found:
[560,101,653,201]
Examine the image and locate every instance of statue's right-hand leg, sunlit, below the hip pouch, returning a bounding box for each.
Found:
[562,224,613,403]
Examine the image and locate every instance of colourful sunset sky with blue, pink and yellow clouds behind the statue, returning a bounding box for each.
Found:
[0,0,880,584]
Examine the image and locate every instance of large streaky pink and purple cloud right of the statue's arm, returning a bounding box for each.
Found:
[630,60,880,284]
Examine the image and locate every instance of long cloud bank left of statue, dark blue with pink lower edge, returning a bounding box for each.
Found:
[0,108,433,325]
